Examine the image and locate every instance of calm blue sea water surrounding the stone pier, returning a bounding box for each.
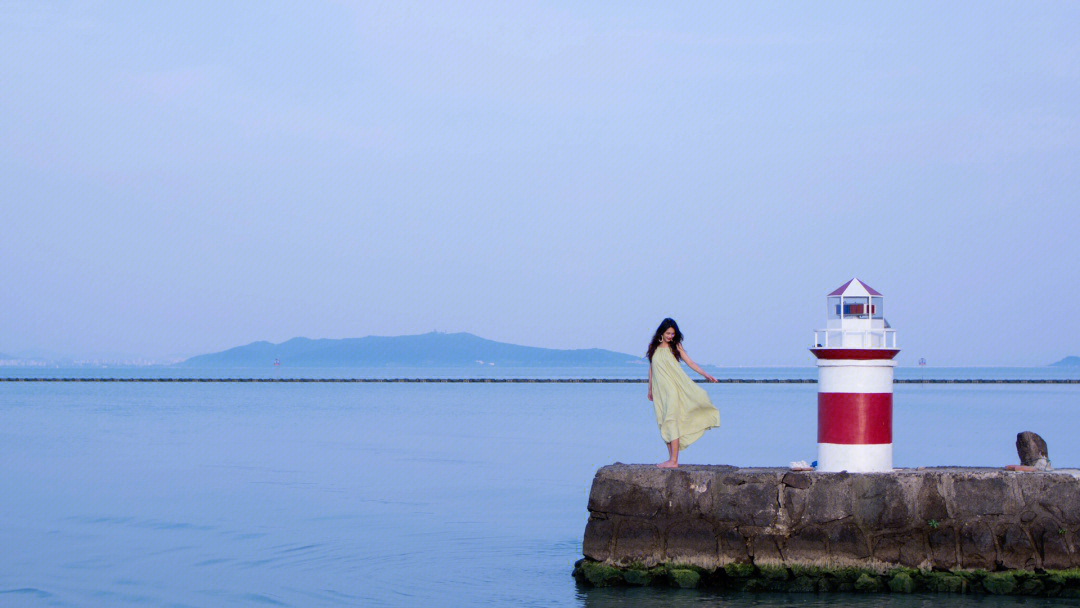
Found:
[0,366,1080,608]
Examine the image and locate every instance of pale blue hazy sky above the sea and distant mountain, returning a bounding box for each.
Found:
[0,0,1080,366]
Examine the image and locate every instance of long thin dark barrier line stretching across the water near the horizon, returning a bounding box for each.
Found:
[0,377,1080,384]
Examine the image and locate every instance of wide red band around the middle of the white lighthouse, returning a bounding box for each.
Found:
[818,393,892,445]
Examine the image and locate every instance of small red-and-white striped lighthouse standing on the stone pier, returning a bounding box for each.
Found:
[810,279,900,473]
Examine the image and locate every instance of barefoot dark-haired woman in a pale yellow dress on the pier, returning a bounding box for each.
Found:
[648,319,720,469]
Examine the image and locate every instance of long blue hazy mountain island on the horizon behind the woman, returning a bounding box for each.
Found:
[179,332,643,367]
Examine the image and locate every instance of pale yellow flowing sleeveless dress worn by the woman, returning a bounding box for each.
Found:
[651,347,720,451]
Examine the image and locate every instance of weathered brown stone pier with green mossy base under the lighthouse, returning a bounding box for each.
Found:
[573,463,1080,597]
